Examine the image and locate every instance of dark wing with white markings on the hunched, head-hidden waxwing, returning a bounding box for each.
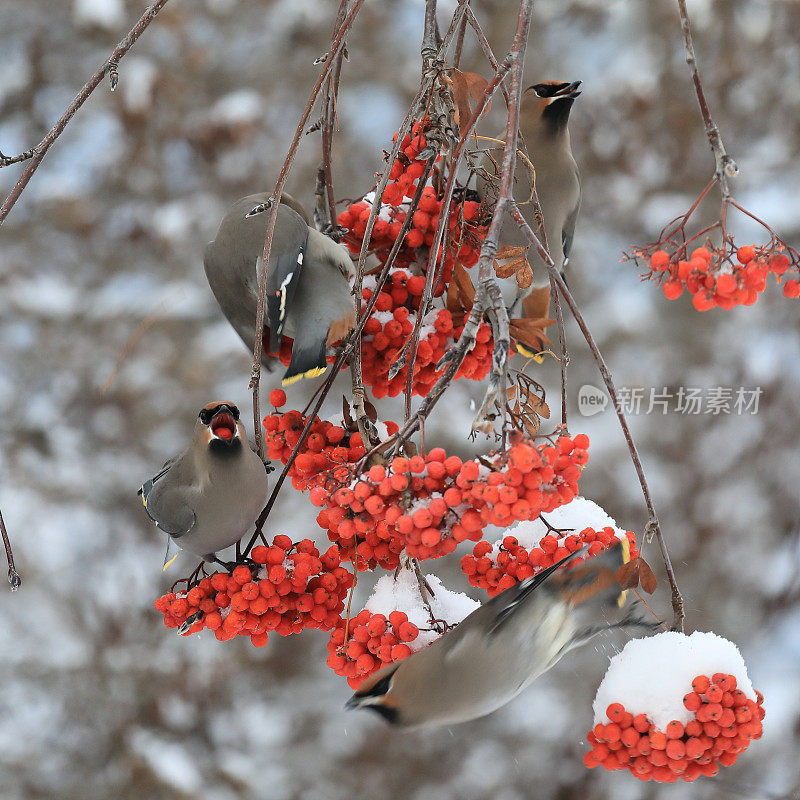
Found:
[266,205,308,353]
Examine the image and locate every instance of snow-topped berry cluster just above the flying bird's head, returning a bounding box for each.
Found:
[328,569,480,689]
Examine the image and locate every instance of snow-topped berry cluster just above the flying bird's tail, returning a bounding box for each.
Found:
[461,490,639,597]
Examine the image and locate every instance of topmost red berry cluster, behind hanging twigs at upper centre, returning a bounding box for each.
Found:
[338,118,485,268]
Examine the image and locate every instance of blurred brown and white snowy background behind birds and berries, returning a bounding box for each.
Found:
[0,0,800,800]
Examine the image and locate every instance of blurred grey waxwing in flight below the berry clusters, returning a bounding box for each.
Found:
[345,544,655,727]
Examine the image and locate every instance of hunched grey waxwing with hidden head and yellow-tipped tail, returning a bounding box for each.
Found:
[204,194,355,385]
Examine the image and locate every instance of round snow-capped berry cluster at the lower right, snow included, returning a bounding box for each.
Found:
[583,631,764,783]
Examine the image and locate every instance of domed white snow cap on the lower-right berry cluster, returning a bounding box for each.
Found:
[592,631,756,731]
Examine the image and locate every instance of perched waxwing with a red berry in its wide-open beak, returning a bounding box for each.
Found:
[139,402,267,568]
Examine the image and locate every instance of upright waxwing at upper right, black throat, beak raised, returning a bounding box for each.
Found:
[478,81,581,318]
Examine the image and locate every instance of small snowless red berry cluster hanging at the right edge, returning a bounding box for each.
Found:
[649,245,800,311]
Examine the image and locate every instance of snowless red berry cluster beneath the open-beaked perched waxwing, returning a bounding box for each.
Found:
[155,536,353,647]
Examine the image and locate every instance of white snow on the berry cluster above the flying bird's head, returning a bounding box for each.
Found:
[364,569,480,652]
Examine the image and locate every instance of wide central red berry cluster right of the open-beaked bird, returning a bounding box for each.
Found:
[310,436,588,570]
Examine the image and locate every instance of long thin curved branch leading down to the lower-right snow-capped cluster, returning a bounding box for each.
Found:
[511,204,685,631]
